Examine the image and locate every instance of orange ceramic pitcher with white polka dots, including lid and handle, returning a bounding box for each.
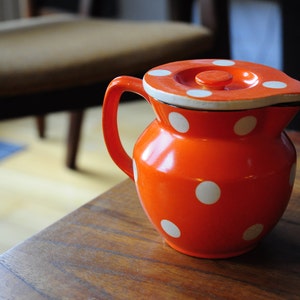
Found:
[103,60,300,258]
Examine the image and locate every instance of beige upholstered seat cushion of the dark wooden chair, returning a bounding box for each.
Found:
[0,15,212,95]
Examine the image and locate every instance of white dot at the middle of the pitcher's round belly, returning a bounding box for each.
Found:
[196,181,221,204]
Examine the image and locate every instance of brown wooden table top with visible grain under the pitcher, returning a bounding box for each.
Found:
[0,137,300,300]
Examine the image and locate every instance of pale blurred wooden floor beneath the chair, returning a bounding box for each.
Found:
[0,100,154,252]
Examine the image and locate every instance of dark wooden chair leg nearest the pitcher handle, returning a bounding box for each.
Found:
[66,110,84,170]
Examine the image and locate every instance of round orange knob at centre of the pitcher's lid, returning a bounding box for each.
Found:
[195,70,233,90]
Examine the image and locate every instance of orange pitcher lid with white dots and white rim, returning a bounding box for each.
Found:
[143,59,300,110]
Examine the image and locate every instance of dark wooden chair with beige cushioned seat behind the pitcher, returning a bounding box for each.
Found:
[0,0,229,169]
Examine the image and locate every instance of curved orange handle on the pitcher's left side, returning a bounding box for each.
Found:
[102,76,149,179]
